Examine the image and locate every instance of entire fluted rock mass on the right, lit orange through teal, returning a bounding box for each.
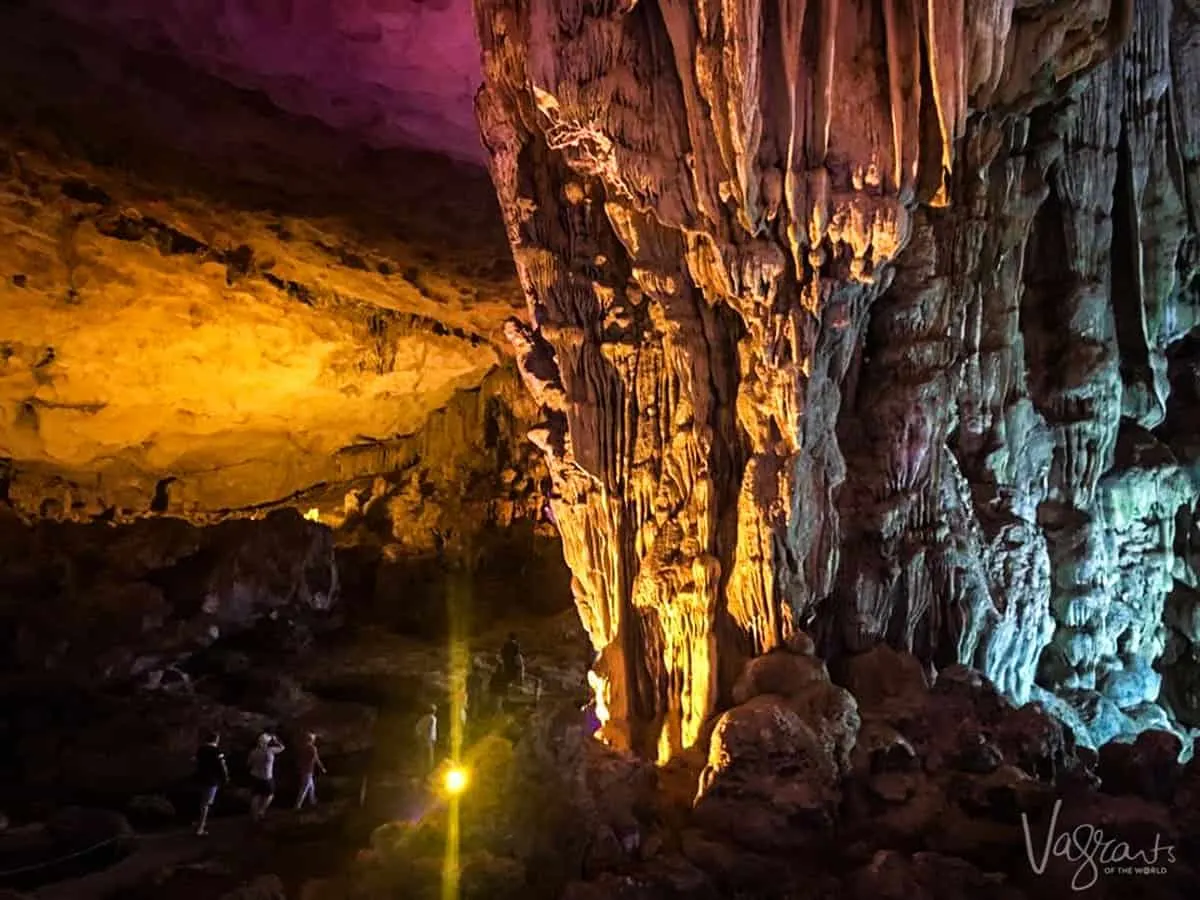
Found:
[475,0,1200,756]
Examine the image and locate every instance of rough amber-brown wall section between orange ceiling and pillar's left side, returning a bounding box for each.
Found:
[308,365,570,637]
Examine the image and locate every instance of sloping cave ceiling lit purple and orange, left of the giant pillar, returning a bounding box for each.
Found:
[0,0,511,518]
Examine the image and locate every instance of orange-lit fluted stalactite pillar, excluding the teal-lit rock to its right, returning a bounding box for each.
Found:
[475,0,1127,758]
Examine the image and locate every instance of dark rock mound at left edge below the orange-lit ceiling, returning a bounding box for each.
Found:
[0,510,340,682]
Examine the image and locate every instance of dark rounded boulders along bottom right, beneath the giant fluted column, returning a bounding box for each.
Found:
[314,648,1200,900]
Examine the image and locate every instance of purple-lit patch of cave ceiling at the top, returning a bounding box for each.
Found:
[55,0,485,163]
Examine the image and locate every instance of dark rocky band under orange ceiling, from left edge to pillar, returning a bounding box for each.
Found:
[0,366,570,689]
